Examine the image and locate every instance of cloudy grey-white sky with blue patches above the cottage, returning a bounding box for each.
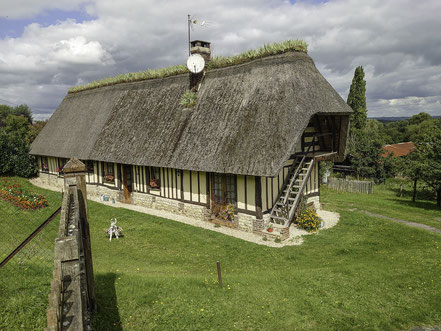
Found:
[0,0,441,120]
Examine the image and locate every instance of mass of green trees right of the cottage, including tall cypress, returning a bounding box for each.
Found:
[345,66,441,207]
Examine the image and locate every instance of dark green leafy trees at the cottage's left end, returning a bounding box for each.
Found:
[0,105,46,178]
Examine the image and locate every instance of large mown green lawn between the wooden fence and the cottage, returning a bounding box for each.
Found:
[0,179,441,330]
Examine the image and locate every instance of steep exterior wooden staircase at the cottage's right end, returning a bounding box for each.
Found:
[270,156,314,227]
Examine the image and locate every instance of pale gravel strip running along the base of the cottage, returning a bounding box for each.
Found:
[30,178,340,247]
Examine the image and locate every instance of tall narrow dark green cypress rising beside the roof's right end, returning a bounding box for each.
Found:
[347,66,367,129]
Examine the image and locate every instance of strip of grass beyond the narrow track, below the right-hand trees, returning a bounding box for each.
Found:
[321,180,441,229]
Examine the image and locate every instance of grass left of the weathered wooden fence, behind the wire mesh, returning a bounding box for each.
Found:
[0,177,61,330]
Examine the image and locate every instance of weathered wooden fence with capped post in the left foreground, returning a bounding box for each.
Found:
[45,159,95,331]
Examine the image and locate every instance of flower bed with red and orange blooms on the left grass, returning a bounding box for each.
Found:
[0,177,49,209]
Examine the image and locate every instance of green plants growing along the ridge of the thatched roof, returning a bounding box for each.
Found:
[69,40,308,93]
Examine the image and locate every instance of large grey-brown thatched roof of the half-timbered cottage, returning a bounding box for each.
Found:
[31,52,351,176]
